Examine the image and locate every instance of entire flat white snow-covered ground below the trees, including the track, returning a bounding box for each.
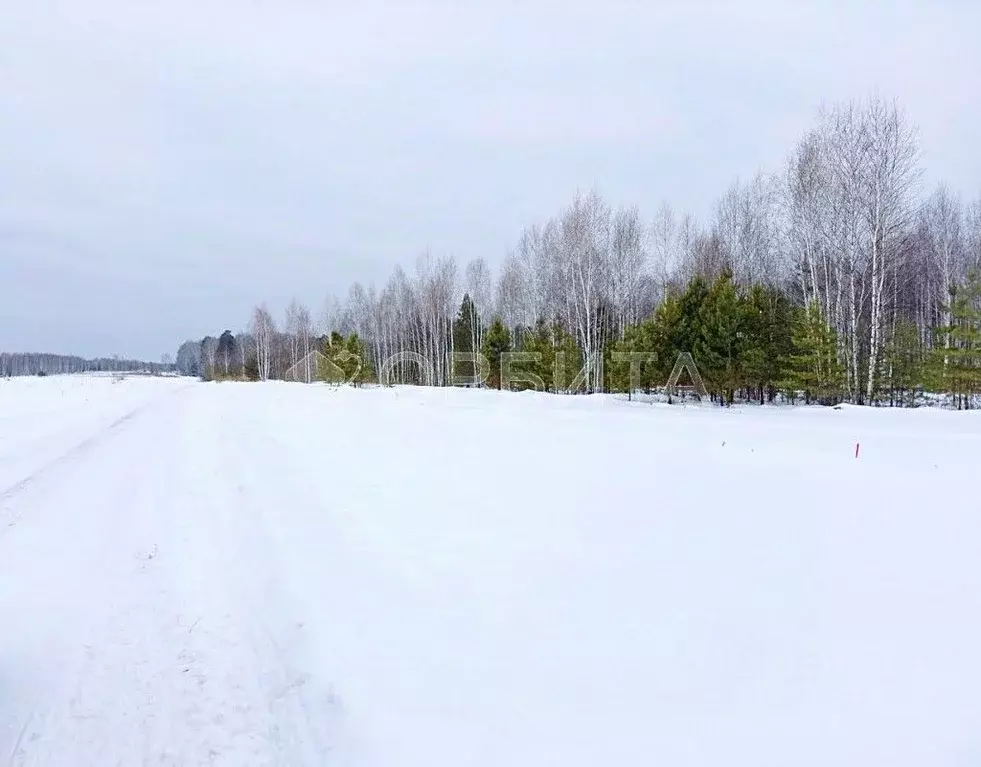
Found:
[0,377,981,767]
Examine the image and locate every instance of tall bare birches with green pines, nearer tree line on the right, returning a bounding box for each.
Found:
[178,97,981,407]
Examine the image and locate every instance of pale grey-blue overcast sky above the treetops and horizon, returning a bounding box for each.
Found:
[0,0,981,359]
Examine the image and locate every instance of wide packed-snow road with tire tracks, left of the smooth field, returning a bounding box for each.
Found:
[0,387,337,767]
